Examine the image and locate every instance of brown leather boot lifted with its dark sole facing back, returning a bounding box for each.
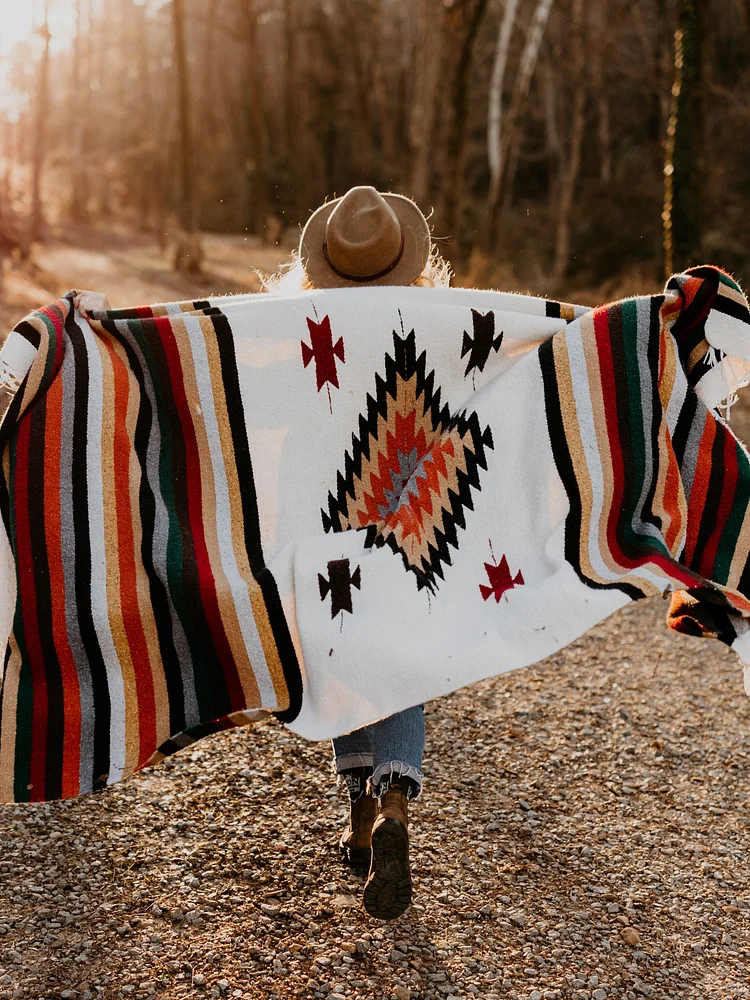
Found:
[363,787,411,920]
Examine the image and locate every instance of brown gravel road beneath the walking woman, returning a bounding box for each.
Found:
[0,600,750,1000]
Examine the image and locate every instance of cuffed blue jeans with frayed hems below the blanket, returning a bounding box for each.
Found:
[333,705,424,791]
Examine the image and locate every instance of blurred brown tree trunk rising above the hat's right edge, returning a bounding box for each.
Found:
[409,0,445,204]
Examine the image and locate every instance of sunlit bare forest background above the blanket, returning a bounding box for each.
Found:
[0,0,750,319]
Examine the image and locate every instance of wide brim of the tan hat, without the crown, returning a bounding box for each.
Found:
[299,193,431,288]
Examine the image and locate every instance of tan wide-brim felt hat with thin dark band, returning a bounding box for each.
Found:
[299,186,431,288]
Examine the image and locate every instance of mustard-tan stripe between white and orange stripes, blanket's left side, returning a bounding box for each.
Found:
[95,336,140,777]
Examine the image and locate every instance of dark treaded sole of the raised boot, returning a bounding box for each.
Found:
[362,820,412,920]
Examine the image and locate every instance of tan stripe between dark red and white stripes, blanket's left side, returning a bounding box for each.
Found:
[181,317,260,706]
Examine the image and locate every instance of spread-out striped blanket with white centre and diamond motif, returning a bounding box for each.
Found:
[0,268,750,801]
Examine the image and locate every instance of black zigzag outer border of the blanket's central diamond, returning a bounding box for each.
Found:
[321,330,493,591]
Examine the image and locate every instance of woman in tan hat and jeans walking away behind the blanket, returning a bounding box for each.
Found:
[267,187,450,920]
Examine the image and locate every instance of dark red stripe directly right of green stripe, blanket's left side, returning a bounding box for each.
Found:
[157,317,245,709]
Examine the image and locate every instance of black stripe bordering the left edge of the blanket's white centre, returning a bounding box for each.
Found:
[213,315,302,722]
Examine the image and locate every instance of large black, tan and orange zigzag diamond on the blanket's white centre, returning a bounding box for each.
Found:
[321,330,493,591]
